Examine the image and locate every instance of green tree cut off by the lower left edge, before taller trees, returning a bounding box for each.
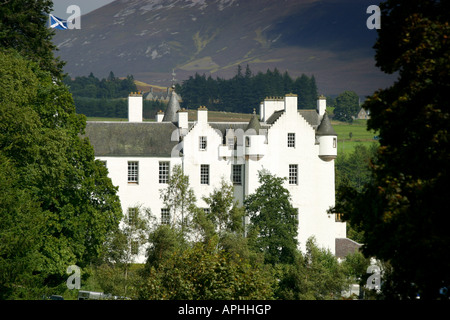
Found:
[0,151,46,300]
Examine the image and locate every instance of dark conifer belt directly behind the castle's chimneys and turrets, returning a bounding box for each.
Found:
[176,65,317,113]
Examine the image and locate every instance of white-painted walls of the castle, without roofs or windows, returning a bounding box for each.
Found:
[98,97,346,262]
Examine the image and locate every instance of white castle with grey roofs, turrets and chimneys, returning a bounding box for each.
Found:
[86,90,351,262]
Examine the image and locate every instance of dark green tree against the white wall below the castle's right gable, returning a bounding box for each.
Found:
[244,171,298,264]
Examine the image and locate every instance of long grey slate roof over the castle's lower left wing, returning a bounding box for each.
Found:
[85,122,178,157]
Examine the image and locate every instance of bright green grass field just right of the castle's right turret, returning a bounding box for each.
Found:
[331,120,378,154]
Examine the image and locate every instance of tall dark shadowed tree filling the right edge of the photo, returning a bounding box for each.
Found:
[335,0,450,299]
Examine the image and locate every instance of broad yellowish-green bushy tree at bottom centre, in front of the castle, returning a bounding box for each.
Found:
[138,243,273,300]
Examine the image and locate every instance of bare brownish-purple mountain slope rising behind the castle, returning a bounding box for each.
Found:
[53,0,394,95]
